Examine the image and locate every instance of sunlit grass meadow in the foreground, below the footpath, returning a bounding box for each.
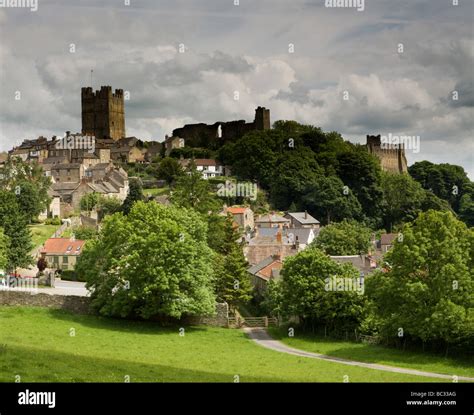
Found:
[0,306,448,382]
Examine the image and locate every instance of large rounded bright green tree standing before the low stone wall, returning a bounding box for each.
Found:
[76,202,215,319]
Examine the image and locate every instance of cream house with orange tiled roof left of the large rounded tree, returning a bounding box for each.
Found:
[41,238,85,271]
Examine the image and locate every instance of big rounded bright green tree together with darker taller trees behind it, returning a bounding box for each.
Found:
[76,165,251,319]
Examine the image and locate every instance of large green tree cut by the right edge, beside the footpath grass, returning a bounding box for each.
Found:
[366,211,474,347]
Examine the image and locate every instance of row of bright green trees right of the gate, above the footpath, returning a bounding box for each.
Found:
[265,210,474,350]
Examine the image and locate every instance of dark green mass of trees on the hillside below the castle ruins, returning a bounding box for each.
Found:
[219,121,462,231]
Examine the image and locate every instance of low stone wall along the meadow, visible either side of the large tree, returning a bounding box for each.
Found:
[0,291,229,327]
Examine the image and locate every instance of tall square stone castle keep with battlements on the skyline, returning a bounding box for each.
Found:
[81,86,125,140]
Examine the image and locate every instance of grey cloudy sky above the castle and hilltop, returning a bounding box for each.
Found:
[0,0,474,179]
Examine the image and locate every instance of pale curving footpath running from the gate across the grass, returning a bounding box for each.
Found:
[244,328,474,382]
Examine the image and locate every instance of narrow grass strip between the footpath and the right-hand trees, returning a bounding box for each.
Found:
[269,328,474,377]
